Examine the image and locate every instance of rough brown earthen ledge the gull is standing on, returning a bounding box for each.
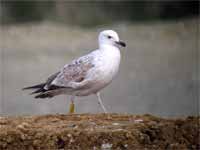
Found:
[0,114,200,150]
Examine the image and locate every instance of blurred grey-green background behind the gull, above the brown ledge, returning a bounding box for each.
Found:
[0,0,200,117]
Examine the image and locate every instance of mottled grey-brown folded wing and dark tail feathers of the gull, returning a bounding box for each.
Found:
[24,52,94,98]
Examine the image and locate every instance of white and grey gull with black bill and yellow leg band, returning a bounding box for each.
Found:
[23,30,126,113]
